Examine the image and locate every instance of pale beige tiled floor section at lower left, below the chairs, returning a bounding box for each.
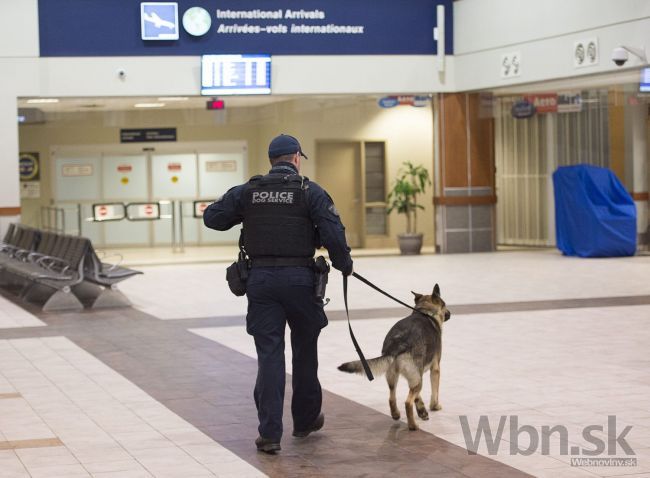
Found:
[0,337,264,478]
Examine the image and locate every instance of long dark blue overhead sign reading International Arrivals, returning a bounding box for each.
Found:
[38,0,453,55]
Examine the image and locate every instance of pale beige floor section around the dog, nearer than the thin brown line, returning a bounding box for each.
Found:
[193,306,650,477]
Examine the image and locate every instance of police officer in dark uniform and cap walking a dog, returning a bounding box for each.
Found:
[203,134,352,453]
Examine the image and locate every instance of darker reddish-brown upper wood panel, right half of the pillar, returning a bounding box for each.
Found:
[467,94,494,187]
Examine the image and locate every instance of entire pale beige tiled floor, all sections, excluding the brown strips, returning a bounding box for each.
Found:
[0,248,650,478]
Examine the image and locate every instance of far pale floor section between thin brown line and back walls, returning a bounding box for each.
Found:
[120,250,650,319]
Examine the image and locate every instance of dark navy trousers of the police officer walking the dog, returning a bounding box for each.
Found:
[246,267,327,440]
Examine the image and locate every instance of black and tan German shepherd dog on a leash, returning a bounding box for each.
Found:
[339,284,451,430]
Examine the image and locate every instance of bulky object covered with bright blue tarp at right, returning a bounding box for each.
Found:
[553,164,636,257]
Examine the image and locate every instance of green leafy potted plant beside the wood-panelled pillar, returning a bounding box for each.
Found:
[387,161,431,255]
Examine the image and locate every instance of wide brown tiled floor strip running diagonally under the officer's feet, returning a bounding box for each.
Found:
[0,300,530,478]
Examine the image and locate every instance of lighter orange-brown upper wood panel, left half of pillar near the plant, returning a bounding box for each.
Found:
[439,93,467,188]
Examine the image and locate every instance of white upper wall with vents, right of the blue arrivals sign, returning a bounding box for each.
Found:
[453,0,650,91]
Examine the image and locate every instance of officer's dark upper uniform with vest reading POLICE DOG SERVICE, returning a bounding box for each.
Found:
[203,162,352,272]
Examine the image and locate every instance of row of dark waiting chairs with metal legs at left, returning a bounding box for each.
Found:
[0,224,141,311]
